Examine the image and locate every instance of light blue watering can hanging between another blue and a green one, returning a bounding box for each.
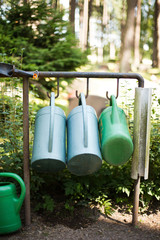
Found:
[67,93,102,176]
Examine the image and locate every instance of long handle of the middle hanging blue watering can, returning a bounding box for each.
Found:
[80,93,88,147]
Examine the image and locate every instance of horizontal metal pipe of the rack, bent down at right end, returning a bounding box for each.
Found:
[12,69,144,87]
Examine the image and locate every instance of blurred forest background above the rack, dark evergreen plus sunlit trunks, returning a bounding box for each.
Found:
[0,0,160,91]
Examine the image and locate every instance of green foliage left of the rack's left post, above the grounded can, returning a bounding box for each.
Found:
[0,80,23,173]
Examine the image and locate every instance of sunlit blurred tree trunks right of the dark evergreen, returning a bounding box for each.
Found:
[68,0,160,72]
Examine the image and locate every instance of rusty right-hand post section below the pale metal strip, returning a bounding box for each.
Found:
[132,176,141,226]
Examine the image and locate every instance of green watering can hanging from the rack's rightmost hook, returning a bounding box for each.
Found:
[99,95,133,165]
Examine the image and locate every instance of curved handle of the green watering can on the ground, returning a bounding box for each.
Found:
[0,172,26,213]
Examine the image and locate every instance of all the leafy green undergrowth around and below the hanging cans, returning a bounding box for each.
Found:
[0,75,160,215]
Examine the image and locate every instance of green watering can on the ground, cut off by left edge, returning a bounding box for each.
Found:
[0,173,26,234]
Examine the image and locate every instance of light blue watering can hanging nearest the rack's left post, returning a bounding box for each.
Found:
[31,93,66,172]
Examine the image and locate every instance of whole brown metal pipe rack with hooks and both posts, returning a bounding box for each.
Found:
[0,63,144,225]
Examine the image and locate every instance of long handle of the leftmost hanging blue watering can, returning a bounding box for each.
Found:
[48,92,55,152]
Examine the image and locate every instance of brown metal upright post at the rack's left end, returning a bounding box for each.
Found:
[23,77,31,225]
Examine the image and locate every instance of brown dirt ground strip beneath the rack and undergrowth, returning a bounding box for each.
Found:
[0,204,160,240]
